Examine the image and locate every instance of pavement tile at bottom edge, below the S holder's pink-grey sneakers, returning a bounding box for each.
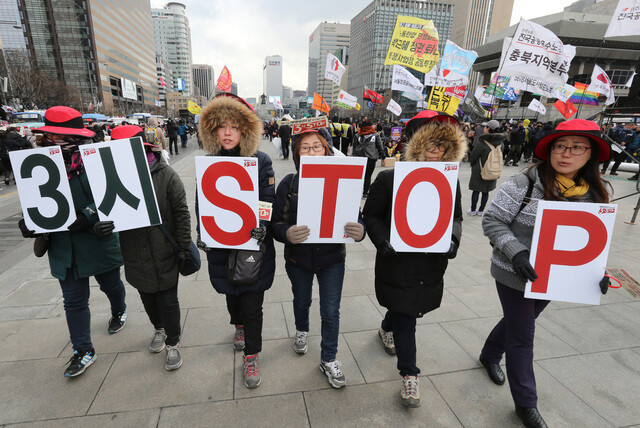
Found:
[158,392,309,428]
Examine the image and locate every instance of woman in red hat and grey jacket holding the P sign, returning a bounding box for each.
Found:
[480,119,610,427]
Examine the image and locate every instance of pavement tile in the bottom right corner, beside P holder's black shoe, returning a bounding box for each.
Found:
[538,349,640,426]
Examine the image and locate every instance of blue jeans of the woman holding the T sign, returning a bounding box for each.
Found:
[285,262,344,362]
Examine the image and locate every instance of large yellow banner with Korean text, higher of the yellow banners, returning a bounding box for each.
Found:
[384,15,440,73]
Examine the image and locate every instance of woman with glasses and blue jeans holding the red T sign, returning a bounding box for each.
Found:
[272,128,365,388]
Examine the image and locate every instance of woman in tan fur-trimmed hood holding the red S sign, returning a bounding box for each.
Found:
[196,93,276,388]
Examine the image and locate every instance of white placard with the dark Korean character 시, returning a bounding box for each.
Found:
[80,137,162,232]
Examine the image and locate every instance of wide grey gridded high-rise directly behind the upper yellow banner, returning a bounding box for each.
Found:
[347,0,453,104]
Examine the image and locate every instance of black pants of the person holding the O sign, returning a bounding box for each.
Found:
[382,311,420,376]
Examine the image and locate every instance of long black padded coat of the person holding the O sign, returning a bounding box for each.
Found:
[363,169,462,318]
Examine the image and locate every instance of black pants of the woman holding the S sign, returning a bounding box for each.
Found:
[226,291,264,355]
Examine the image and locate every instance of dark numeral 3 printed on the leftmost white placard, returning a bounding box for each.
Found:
[20,154,71,230]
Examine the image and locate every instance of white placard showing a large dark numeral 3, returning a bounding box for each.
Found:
[9,146,76,233]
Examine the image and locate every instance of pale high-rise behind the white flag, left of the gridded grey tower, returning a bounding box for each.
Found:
[307,22,351,105]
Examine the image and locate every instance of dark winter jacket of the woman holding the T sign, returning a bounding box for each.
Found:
[271,174,366,272]
